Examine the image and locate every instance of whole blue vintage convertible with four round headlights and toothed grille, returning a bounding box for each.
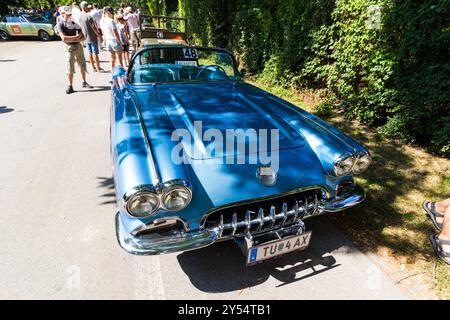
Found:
[111,45,371,265]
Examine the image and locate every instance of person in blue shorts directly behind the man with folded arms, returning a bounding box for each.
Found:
[80,1,104,72]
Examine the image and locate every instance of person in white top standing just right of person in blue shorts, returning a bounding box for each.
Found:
[101,7,123,72]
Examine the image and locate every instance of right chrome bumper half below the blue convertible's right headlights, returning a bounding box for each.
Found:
[318,185,366,212]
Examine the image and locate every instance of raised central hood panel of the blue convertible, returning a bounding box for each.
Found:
[148,82,305,159]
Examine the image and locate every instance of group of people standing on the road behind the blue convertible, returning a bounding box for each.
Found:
[54,1,139,94]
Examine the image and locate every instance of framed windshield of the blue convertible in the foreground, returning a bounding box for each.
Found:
[129,47,239,84]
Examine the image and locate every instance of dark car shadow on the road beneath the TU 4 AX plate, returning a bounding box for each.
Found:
[177,218,348,293]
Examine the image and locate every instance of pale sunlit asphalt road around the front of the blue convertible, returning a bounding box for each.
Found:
[0,41,409,299]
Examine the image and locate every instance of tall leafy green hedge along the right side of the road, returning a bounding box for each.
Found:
[179,0,450,156]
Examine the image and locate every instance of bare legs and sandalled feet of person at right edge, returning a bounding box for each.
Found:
[423,198,450,265]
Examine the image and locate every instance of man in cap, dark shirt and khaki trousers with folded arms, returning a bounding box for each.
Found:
[56,7,92,94]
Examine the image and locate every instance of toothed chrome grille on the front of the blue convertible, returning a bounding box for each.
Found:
[203,189,322,238]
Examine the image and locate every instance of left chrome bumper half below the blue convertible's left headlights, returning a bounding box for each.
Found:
[116,213,219,255]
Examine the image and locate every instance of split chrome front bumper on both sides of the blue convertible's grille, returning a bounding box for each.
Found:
[116,185,365,255]
